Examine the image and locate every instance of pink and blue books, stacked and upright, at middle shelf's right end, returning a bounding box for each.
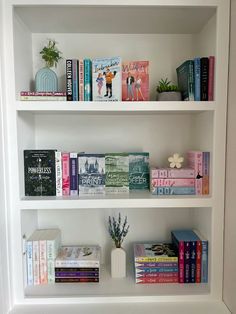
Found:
[150,151,210,195]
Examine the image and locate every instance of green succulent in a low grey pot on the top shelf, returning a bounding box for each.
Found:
[156,78,181,101]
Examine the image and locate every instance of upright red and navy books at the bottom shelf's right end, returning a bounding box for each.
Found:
[171,230,208,283]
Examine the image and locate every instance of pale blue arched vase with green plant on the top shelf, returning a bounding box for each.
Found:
[35,39,62,92]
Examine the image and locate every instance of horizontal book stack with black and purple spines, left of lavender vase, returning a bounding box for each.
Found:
[55,245,101,283]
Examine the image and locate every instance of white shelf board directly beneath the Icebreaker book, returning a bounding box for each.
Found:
[16,101,216,114]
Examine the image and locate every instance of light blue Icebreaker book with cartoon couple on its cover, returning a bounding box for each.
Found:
[92,57,121,101]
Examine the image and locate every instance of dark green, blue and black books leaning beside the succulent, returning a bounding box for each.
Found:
[176,56,215,101]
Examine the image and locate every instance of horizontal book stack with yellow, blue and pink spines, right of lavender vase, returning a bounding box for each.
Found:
[134,243,178,284]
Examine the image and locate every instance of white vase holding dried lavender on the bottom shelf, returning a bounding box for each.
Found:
[108,213,129,278]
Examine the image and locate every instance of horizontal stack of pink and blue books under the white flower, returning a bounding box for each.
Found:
[151,168,195,195]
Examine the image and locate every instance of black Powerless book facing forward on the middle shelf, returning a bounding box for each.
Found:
[24,149,56,196]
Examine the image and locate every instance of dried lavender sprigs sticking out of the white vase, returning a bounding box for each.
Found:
[108,213,129,248]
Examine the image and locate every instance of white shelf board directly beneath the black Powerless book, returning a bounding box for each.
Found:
[19,192,213,209]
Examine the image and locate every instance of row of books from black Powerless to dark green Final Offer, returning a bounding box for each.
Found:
[24,150,150,196]
